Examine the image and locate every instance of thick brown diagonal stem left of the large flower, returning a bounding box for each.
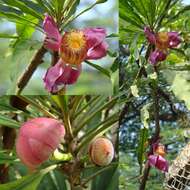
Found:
[16,46,47,95]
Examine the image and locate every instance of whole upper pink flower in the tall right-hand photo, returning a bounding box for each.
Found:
[144,27,181,65]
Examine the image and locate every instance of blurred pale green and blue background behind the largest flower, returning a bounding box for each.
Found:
[0,0,118,95]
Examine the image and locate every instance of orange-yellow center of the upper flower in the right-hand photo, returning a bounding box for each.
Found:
[156,32,169,49]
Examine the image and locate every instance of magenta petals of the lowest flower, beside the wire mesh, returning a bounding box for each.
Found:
[148,155,168,172]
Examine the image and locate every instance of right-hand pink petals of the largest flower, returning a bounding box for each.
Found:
[84,28,108,59]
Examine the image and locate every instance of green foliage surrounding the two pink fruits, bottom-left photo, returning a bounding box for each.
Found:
[0,96,120,190]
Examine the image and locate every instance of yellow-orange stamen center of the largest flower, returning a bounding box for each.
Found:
[60,30,87,65]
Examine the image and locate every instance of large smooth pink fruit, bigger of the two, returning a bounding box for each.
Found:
[16,117,65,170]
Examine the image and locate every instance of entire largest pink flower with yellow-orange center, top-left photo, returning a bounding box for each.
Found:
[43,15,108,93]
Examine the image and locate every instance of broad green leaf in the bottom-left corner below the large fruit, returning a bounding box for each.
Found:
[0,166,56,190]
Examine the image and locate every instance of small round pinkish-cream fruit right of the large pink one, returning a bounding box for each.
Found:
[89,137,114,166]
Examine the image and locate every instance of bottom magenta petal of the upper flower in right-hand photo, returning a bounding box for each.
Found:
[149,49,167,65]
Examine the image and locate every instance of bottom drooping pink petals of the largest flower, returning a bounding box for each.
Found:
[43,59,81,93]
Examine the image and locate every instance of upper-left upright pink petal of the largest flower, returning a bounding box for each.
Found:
[43,14,61,51]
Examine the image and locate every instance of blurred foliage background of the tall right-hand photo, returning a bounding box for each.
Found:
[118,0,190,190]
